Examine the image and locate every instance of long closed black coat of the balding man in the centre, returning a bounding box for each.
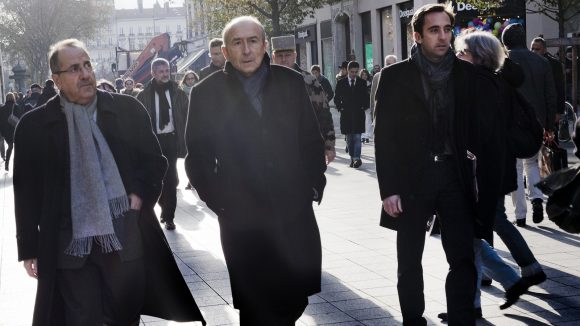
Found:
[185,55,326,310]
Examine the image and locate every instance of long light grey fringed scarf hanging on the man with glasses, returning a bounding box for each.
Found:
[60,94,129,257]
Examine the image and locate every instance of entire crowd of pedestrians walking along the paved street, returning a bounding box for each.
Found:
[5,4,577,326]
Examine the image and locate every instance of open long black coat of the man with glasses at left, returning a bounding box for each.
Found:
[14,91,203,325]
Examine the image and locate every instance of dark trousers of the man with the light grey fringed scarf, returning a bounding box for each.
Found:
[56,245,145,326]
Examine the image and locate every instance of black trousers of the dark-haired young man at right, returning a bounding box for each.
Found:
[397,160,477,325]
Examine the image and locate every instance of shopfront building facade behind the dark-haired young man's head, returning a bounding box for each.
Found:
[295,0,558,86]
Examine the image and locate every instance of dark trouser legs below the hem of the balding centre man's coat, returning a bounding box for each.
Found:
[240,293,308,326]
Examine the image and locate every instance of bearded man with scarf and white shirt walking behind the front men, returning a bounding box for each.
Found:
[137,58,189,230]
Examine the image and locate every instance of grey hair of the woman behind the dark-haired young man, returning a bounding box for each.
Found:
[455,31,506,71]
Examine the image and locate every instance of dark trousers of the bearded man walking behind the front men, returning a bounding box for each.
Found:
[157,132,179,221]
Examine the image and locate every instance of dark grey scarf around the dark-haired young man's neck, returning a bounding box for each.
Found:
[411,44,455,153]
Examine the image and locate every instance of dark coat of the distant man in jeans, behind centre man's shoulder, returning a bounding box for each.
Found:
[334,77,369,134]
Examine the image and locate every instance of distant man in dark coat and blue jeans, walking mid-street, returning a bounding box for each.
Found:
[334,61,369,169]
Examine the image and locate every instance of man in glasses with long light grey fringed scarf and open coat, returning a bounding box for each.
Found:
[14,39,203,326]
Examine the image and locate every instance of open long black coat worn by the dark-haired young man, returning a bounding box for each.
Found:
[375,59,503,239]
